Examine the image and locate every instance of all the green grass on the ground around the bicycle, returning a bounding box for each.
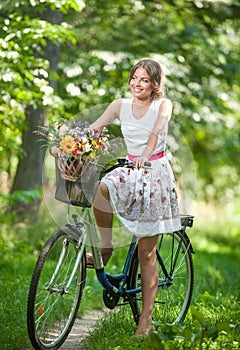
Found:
[0,204,240,350]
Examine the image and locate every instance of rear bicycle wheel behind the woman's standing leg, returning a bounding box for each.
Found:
[128,231,194,325]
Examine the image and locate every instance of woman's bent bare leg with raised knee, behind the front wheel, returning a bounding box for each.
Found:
[93,183,113,248]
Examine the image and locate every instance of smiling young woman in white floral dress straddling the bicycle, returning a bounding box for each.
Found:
[88,59,181,336]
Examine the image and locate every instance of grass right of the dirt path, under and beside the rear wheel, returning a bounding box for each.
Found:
[85,204,240,350]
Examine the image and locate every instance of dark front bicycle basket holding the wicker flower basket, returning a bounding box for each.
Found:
[55,157,103,207]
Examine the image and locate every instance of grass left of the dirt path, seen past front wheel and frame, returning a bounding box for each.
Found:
[0,206,130,350]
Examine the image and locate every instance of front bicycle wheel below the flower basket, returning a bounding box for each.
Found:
[27,230,86,350]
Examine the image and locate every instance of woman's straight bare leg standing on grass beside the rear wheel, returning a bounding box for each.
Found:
[135,236,158,336]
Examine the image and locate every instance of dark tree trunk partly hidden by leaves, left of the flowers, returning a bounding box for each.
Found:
[11,8,62,221]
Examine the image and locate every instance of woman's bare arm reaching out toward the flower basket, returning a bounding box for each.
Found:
[90,99,122,130]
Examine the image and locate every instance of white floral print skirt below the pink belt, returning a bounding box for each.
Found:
[101,157,181,237]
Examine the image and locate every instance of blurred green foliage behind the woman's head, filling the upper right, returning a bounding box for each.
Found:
[59,0,240,199]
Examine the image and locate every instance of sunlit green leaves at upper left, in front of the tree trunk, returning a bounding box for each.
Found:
[0,0,80,169]
